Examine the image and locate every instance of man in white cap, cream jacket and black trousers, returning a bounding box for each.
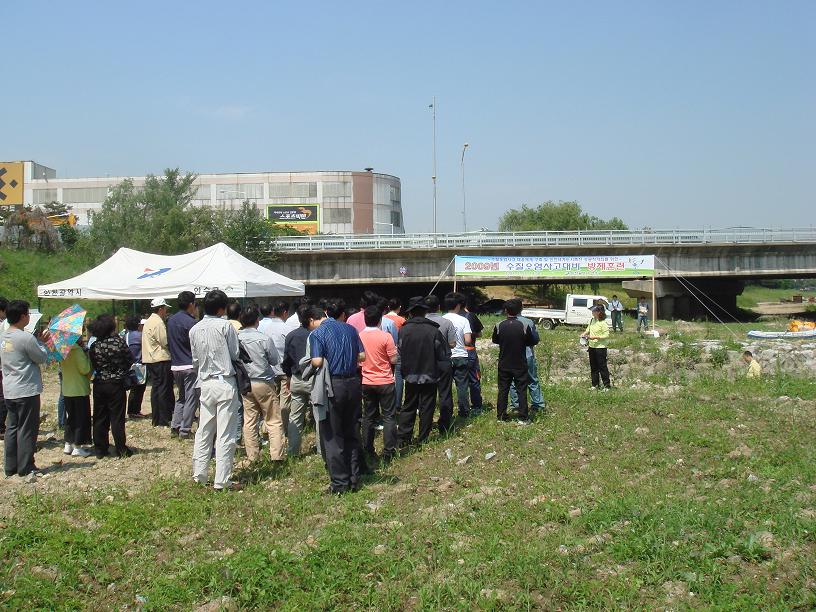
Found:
[142,298,176,427]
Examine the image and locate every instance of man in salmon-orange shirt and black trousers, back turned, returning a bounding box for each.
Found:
[360,306,397,465]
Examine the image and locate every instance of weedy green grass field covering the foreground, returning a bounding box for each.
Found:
[0,326,816,610]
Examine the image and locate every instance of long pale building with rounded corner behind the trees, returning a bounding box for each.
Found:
[0,161,405,234]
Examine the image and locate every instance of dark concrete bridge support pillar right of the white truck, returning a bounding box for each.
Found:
[623,278,745,320]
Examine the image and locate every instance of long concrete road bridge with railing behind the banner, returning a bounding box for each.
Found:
[269,228,816,317]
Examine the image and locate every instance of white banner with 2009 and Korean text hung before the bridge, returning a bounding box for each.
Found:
[454,255,654,278]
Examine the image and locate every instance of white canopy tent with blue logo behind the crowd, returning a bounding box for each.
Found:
[37,243,305,300]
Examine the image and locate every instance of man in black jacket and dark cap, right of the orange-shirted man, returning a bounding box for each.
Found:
[397,297,450,448]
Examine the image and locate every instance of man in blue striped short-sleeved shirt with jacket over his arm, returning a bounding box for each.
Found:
[309,304,365,494]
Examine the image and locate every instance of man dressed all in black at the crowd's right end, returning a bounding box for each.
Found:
[493,298,538,424]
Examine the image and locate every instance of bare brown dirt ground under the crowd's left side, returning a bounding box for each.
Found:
[0,368,314,517]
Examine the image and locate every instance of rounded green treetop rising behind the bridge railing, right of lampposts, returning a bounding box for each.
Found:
[499,200,627,232]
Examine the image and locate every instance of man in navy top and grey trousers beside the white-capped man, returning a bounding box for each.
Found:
[167,291,199,439]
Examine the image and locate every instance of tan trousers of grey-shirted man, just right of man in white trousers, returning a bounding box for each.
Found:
[243,380,286,461]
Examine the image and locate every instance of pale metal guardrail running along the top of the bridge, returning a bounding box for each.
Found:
[262,227,816,252]
